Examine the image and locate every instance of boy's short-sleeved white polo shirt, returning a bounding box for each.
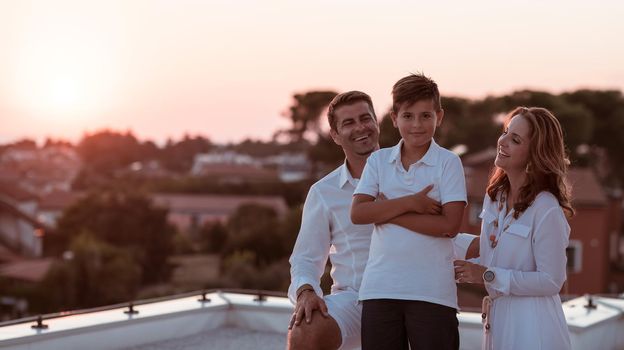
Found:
[355,140,466,309]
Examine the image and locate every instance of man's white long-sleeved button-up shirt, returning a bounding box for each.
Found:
[288,160,476,303]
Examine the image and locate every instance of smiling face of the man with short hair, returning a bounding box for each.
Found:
[330,101,379,159]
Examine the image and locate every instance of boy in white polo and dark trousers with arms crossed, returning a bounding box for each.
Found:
[351,74,466,350]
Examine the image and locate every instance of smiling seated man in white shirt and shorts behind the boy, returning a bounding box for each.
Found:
[287,91,478,350]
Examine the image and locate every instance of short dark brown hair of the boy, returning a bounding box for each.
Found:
[392,73,442,114]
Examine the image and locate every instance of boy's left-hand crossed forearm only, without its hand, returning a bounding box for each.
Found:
[351,195,409,225]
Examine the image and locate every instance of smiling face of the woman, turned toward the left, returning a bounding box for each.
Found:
[494,115,531,174]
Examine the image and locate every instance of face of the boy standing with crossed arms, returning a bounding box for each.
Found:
[391,99,444,148]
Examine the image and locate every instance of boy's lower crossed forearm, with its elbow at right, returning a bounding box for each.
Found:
[384,201,466,237]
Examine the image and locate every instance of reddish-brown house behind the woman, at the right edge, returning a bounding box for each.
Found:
[461,148,624,295]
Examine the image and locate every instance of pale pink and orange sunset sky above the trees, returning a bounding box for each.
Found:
[0,0,624,143]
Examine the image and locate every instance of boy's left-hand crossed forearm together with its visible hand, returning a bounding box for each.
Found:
[351,185,439,225]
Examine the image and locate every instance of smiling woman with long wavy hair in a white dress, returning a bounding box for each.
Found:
[455,107,574,349]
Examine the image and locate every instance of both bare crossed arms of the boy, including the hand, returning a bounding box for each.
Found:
[351,185,465,237]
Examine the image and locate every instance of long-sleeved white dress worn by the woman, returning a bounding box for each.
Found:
[477,192,570,350]
